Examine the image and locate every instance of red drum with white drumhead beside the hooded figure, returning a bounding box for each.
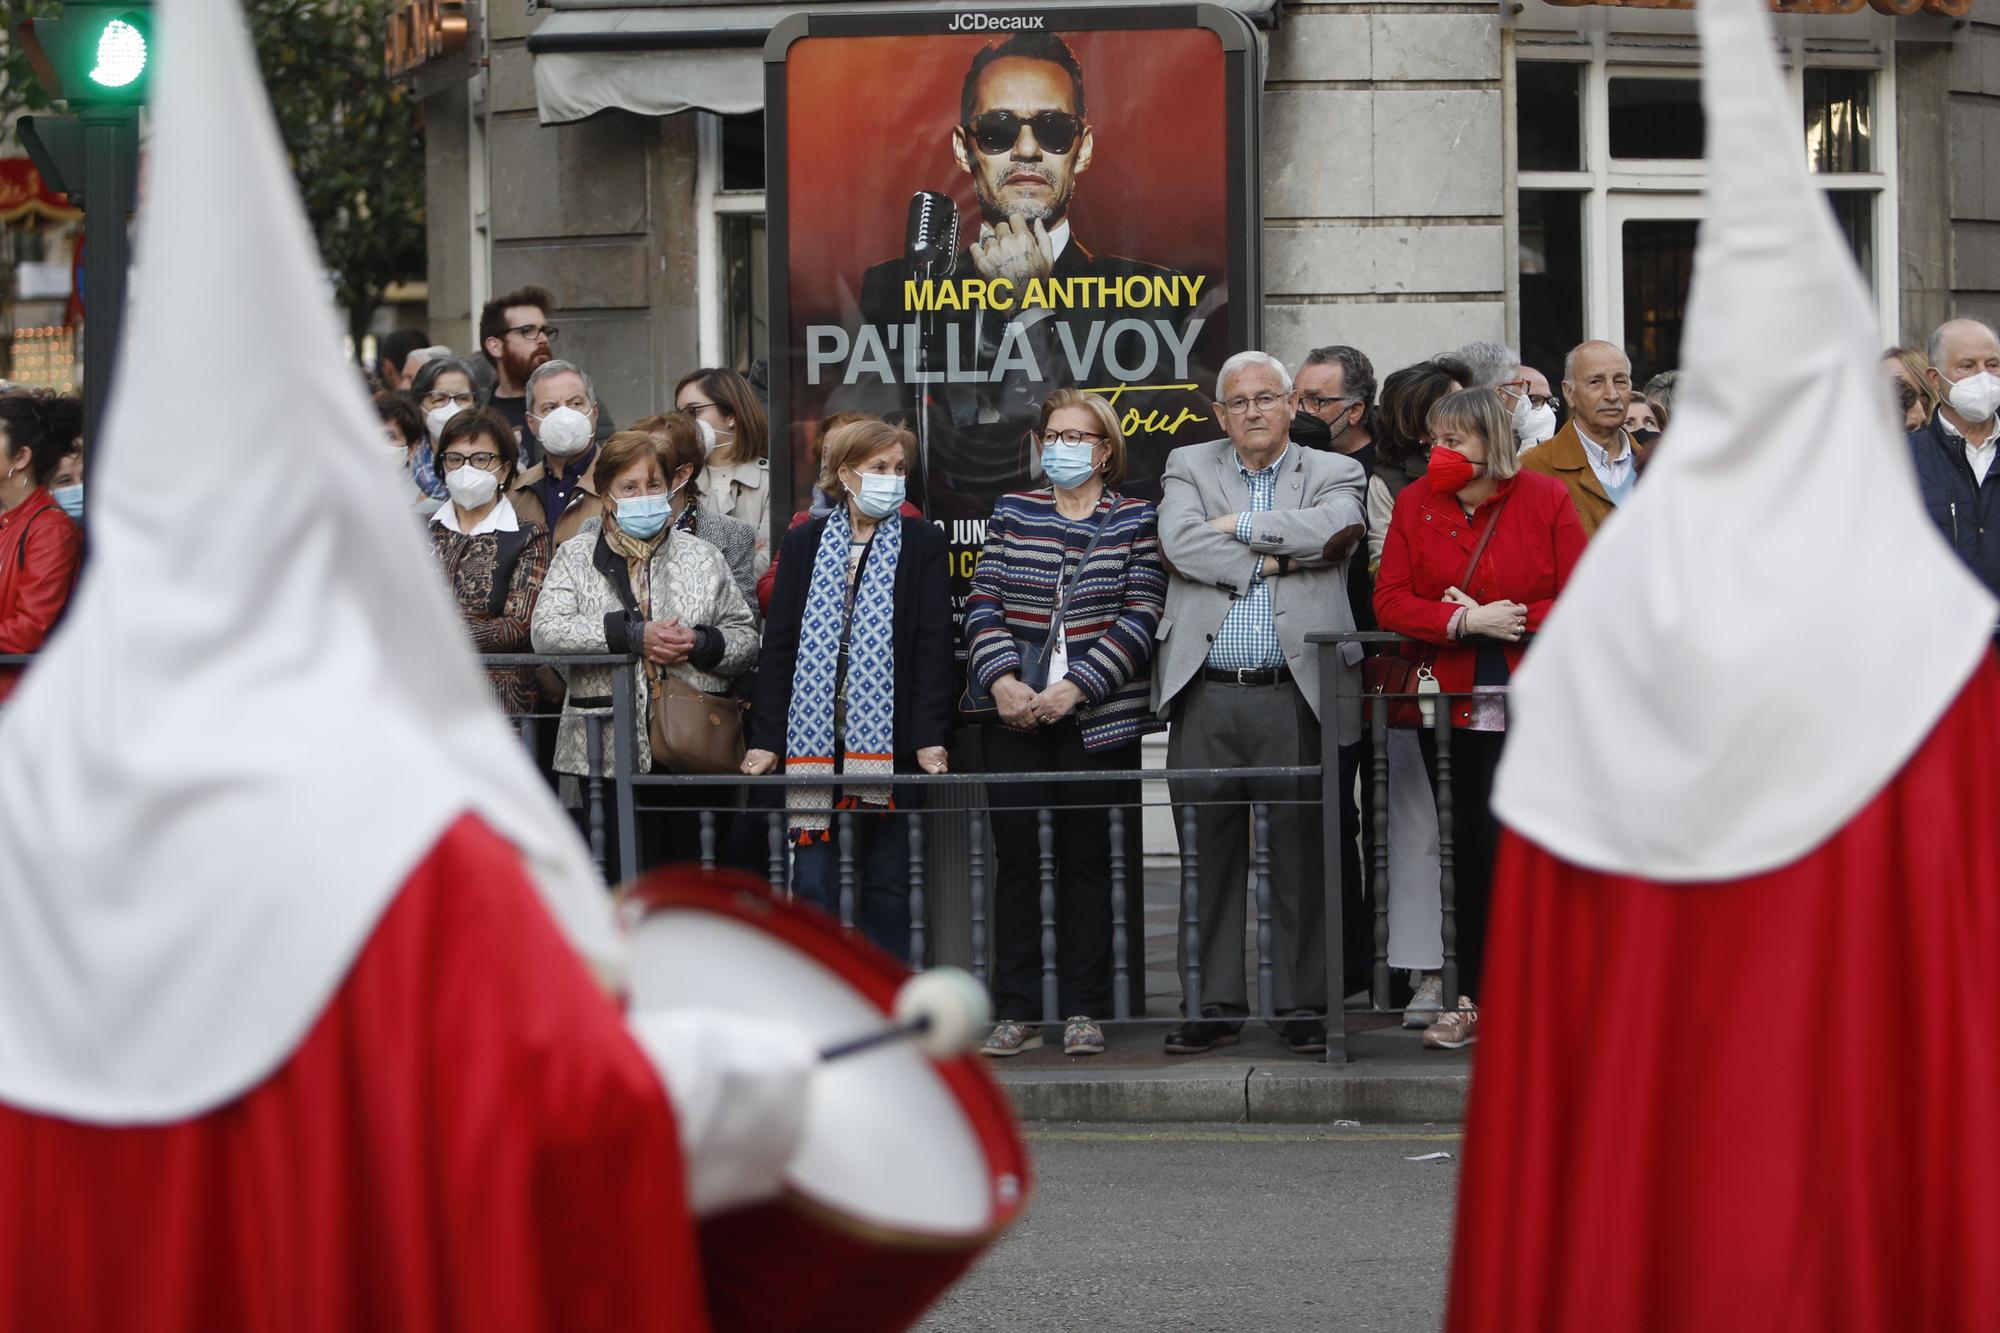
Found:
[628,869,1030,1333]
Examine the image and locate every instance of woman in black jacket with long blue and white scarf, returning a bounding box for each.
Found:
[744,418,958,967]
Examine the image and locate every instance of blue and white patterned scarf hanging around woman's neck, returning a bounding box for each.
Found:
[784,504,902,839]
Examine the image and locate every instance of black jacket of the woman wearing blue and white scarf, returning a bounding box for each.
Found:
[750,514,958,773]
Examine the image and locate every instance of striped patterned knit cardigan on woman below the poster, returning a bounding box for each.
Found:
[966,490,1166,751]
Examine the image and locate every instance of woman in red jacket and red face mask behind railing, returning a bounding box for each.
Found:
[1374,388,1584,1051]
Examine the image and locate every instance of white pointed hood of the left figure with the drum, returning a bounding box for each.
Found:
[0,0,618,1123]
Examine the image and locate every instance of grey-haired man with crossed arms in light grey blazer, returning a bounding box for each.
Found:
[1152,352,1364,1055]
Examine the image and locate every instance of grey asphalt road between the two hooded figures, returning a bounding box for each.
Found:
[918,1125,1458,1333]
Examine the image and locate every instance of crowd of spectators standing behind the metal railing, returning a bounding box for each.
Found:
[0,272,2000,1057]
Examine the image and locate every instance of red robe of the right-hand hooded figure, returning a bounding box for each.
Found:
[1448,656,2000,1333]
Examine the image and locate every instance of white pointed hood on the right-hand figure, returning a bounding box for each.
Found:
[1494,0,1996,881]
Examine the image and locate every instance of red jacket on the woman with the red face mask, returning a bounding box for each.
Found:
[1376,472,1586,727]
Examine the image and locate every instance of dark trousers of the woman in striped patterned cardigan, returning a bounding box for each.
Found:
[984,717,1144,1023]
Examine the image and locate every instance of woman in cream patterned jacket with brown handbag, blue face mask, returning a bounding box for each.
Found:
[534,430,758,877]
